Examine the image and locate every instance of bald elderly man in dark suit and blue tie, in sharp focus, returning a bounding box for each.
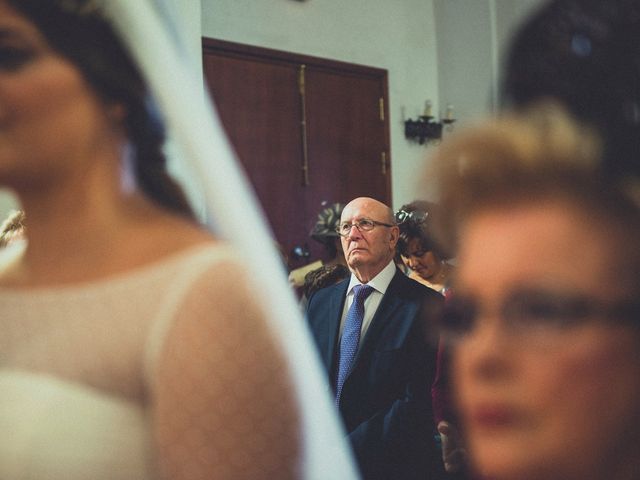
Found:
[307,197,443,480]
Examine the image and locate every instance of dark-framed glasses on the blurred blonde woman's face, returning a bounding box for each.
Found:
[440,290,640,344]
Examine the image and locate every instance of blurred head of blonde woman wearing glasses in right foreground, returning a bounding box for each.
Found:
[434,107,640,480]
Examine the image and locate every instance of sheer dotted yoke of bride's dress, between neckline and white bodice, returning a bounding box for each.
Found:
[0,246,228,403]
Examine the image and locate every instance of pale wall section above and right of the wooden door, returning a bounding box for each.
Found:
[202,0,438,206]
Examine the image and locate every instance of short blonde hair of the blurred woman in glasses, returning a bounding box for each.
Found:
[426,103,640,268]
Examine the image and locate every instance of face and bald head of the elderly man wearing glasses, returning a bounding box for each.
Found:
[340,198,398,282]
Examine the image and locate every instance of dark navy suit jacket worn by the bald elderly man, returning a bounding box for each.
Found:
[307,270,443,480]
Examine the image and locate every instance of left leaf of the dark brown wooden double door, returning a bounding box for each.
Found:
[204,55,304,255]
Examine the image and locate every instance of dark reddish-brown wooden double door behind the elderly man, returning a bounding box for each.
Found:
[203,39,391,267]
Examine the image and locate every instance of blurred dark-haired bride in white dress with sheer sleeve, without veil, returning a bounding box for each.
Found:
[0,0,352,480]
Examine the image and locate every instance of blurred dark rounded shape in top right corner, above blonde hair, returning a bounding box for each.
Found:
[502,0,640,182]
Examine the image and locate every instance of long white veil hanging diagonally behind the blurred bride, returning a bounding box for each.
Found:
[102,0,358,480]
